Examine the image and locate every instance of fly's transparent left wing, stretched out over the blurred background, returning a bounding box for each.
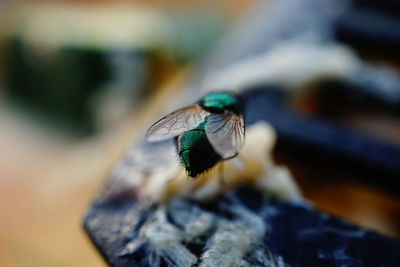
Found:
[146,105,208,142]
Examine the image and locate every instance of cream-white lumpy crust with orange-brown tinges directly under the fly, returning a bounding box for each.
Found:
[101,122,303,203]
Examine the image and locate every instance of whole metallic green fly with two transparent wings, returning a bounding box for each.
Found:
[146,92,245,177]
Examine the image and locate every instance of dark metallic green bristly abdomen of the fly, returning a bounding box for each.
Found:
[177,123,221,177]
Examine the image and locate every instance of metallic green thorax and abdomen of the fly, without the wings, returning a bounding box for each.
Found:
[177,92,243,177]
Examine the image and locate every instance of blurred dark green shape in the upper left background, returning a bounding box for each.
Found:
[5,38,151,133]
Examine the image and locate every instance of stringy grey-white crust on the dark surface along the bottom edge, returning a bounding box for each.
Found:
[120,197,286,267]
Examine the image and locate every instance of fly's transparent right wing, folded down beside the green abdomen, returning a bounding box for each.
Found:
[205,112,245,159]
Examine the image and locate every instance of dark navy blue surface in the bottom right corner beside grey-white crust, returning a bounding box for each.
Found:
[262,203,400,266]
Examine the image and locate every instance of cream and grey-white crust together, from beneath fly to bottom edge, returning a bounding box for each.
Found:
[102,122,296,267]
